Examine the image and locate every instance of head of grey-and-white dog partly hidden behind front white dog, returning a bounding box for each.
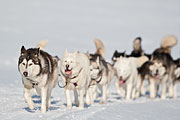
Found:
[90,56,102,79]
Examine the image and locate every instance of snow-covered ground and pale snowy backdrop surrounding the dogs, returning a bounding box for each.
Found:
[0,0,180,120]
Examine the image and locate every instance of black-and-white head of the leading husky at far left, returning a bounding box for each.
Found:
[18,46,40,78]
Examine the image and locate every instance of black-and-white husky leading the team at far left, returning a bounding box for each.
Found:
[18,41,58,113]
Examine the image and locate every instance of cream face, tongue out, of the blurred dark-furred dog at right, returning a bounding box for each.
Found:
[149,61,166,79]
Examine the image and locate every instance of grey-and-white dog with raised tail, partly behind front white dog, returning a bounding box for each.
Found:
[88,39,115,104]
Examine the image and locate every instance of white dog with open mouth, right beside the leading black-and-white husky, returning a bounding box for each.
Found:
[60,50,91,108]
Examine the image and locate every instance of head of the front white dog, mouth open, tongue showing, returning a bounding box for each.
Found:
[61,49,78,77]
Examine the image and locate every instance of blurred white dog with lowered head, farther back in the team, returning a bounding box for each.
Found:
[114,57,138,100]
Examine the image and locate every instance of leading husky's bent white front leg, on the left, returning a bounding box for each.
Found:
[24,88,34,110]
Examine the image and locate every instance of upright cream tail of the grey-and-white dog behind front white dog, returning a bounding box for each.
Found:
[94,39,105,57]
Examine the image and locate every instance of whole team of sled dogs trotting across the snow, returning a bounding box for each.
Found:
[18,35,180,113]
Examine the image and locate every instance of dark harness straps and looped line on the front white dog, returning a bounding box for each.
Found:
[58,68,82,88]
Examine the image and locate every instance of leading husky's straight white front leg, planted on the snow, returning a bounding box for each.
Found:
[41,86,47,113]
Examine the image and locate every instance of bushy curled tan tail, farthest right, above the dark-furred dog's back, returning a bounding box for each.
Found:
[161,35,177,53]
